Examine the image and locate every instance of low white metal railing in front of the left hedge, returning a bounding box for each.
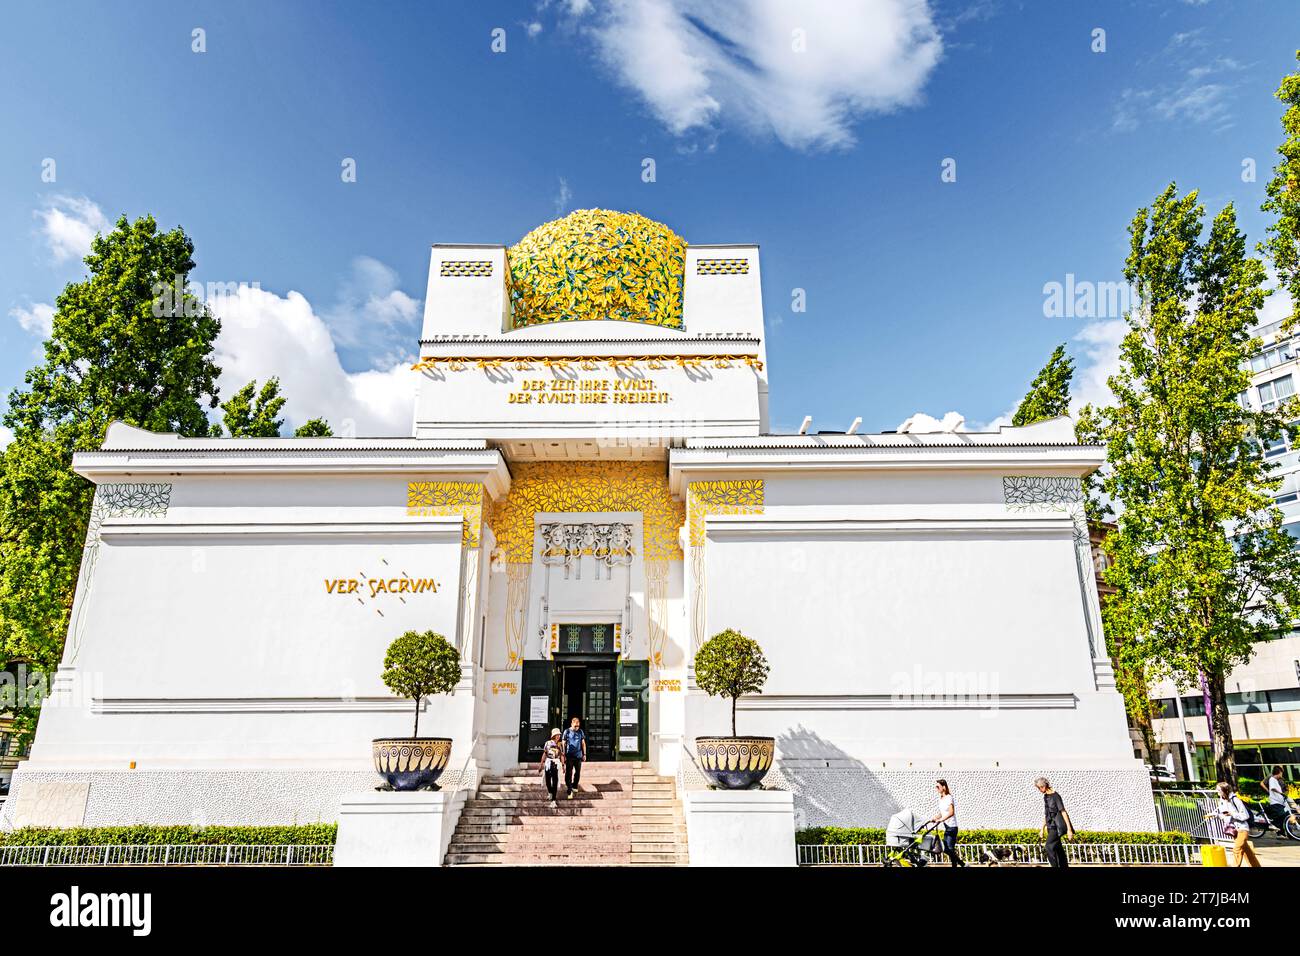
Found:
[0,843,334,866]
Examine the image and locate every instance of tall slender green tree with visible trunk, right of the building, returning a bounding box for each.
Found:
[1101,185,1300,782]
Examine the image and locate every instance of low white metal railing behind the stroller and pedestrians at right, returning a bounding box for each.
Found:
[797,843,1201,866]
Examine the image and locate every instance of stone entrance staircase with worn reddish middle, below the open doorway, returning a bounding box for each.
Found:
[446,762,686,866]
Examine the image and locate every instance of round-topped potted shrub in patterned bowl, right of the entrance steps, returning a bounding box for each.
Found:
[696,628,776,790]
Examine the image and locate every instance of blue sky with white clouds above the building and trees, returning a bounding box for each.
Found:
[0,0,1300,440]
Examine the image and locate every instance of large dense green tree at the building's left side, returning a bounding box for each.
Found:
[0,216,221,670]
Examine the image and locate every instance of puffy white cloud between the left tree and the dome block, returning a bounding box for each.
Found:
[211,282,419,437]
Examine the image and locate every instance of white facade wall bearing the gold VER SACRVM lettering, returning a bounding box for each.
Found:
[9,475,488,823]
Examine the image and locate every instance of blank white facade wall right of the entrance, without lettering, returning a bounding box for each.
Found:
[685,468,1154,830]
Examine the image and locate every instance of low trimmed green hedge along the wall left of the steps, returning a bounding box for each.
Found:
[0,823,338,847]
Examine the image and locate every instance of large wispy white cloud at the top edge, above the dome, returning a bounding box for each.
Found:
[568,0,943,150]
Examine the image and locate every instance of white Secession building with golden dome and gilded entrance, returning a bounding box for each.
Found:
[5,211,1154,829]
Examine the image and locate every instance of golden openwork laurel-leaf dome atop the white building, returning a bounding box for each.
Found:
[510,209,686,329]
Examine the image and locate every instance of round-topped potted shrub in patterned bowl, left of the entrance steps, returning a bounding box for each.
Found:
[373,631,460,790]
